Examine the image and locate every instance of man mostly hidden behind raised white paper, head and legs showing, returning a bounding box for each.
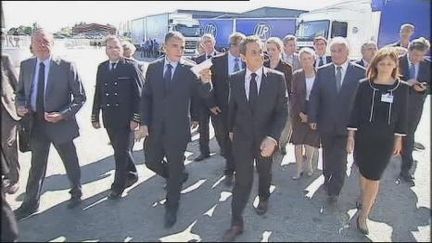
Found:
[193,34,219,161]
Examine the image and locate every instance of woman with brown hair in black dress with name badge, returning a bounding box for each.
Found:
[347,48,409,234]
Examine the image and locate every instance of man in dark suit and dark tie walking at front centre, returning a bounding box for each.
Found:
[223,36,288,241]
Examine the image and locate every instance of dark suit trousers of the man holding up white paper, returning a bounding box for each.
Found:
[144,133,187,210]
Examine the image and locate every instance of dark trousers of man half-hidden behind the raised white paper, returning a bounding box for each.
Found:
[198,102,211,155]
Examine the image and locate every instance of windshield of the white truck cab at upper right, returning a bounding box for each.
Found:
[296,20,330,41]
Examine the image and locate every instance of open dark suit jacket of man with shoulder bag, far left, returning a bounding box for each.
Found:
[15,56,86,144]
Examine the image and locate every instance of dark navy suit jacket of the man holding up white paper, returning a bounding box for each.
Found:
[141,58,211,148]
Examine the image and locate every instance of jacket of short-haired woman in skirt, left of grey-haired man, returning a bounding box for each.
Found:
[290,69,307,119]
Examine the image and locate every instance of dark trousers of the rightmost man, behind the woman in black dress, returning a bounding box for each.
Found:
[401,105,423,175]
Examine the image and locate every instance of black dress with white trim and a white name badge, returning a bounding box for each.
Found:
[348,80,409,180]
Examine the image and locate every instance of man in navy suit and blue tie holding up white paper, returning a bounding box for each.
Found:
[136,32,211,227]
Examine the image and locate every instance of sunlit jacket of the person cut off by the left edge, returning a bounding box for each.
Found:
[1,55,21,121]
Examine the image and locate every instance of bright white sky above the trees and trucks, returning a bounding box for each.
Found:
[2,0,343,31]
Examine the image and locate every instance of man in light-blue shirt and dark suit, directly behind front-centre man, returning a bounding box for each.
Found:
[207,32,246,186]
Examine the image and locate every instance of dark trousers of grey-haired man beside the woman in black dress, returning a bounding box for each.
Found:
[321,134,347,196]
